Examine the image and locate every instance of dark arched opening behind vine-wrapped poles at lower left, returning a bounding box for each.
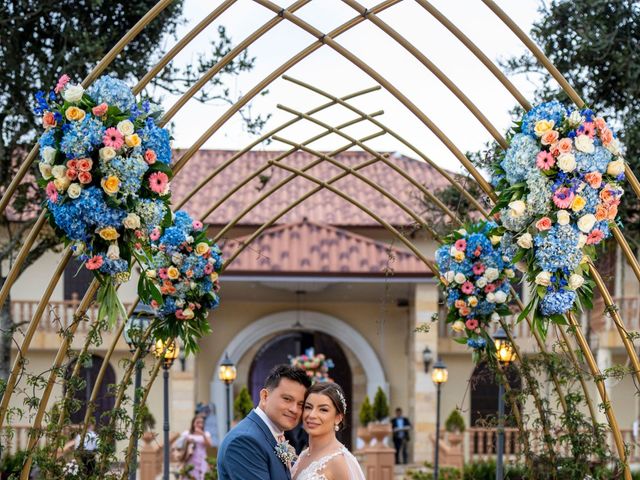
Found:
[65,355,116,427]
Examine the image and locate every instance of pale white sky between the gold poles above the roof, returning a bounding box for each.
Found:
[158,0,538,171]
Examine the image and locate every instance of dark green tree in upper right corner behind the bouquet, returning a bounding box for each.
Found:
[504,0,640,243]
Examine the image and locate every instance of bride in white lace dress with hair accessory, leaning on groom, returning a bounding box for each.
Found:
[291,383,365,480]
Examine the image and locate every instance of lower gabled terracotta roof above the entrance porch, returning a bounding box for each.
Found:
[222,221,431,276]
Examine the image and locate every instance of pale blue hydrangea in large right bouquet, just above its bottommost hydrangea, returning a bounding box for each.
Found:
[534,224,582,272]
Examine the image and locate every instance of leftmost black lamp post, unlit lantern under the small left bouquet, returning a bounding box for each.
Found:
[122,303,155,480]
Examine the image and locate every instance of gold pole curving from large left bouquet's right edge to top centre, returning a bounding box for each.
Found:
[167,0,401,174]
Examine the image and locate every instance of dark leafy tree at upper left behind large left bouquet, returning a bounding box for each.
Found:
[0,0,266,382]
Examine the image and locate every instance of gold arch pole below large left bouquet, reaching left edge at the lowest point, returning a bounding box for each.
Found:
[0,249,71,429]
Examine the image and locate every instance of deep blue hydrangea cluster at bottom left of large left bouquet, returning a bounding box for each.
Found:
[49,187,127,241]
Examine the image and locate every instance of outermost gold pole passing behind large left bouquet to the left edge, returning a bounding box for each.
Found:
[0,0,173,216]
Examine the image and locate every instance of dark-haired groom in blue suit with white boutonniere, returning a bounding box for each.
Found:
[218,365,311,480]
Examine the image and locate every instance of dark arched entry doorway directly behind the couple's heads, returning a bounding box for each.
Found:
[247,331,353,448]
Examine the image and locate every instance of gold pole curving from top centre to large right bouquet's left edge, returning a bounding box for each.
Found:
[342,0,507,149]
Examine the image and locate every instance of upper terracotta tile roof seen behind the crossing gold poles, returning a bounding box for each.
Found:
[172,150,447,226]
